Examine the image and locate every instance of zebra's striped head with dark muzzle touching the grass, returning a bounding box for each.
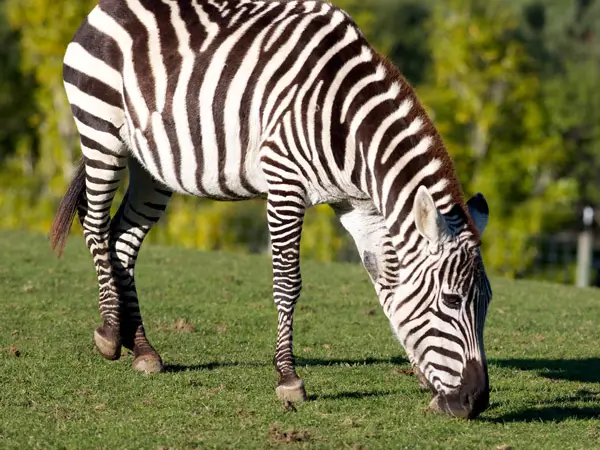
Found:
[392,186,492,419]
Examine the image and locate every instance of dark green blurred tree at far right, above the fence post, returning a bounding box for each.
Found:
[523,0,600,212]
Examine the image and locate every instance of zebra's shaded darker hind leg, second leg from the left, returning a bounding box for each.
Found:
[110,159,172,373]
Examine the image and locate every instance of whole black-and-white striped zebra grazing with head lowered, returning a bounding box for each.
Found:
[50,0,492,418]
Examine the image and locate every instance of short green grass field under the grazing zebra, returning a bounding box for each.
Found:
[0,231,600,449]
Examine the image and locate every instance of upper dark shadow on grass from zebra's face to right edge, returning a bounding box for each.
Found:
[489,358,600,383]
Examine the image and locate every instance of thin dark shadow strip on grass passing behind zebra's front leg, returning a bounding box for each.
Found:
[165,357,408,373]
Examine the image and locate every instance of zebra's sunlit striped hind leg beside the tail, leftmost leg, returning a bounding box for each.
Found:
[77,153,127,360]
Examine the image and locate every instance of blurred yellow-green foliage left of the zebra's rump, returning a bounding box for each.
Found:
[0,0,96,231]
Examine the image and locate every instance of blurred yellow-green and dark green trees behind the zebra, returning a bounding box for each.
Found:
[0,0,600,277]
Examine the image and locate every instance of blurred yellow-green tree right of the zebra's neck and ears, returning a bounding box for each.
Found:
[420,0,576,275]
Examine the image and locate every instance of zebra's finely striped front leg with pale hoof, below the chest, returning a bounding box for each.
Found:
[267,195,306,403]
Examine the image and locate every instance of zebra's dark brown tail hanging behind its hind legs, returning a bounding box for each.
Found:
[50,158,85,257]
